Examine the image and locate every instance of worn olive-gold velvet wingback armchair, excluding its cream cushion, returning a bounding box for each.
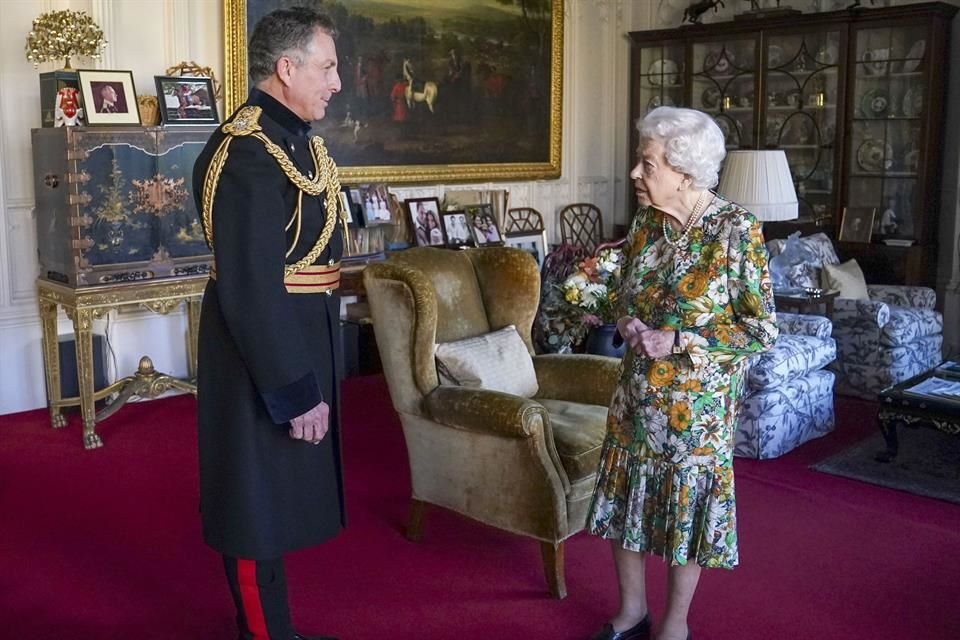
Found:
[363,248,619,598]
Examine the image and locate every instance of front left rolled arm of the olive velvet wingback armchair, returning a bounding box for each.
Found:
[423,385,549,438]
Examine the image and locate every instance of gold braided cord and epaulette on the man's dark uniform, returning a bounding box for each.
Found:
[202,107,347,276]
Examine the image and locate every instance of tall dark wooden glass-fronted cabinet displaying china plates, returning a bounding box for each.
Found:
[630,2,957,285]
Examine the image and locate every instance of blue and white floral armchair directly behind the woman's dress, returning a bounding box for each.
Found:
[734,313,837,459]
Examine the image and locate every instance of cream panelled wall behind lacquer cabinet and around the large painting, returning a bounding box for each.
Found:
[0,0,632,414]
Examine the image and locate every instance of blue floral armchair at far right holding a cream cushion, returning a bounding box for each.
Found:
[767,233,943,399]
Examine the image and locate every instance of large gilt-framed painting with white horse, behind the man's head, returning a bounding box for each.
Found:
[223,0,569,184]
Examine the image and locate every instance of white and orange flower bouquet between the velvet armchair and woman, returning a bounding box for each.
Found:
[560,248,623,326]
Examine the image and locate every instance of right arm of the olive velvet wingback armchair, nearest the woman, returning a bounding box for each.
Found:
[533,354,620,407]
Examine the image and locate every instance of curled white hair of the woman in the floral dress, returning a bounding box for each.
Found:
[637,107,727,189]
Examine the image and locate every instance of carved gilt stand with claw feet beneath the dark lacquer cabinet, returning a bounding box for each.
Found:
[37,275,207,449]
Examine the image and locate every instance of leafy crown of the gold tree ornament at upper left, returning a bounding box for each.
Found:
[26,10,107,69]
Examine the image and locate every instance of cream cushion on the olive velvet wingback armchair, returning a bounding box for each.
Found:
[436,324,540,398]
